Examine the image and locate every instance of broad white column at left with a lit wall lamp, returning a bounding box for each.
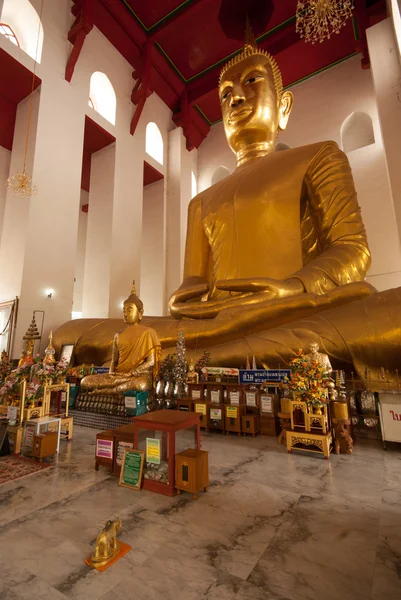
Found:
[13,79,86,356]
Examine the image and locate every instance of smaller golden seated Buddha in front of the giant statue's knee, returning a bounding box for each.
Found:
[81,282,161,394]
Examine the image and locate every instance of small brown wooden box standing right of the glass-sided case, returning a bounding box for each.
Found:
[175,449,209,500]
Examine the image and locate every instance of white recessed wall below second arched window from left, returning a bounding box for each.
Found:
[82,144,116,318]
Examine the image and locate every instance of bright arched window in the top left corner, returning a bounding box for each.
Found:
[0,0,43,63]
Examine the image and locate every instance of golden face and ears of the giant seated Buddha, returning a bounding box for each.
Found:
[219,54,293,153]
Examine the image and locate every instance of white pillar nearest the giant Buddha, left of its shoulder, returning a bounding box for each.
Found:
[166,127,197,298]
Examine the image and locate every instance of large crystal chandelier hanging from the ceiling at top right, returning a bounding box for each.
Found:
[296,0,354,44]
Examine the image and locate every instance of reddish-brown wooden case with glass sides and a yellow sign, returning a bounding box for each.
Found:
[134,410,200,496]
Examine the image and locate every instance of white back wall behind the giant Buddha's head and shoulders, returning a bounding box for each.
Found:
[198,56,401,290]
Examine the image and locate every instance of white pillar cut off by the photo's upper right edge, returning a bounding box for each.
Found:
[366,18,401,241]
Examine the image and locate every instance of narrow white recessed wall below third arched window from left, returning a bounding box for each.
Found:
[141,179,166,316]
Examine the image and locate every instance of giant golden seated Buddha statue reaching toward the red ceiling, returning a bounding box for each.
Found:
[56,34,401,390]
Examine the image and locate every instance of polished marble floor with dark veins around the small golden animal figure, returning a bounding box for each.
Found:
[0,427,401,600]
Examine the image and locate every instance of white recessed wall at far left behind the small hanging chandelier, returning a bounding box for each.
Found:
[0,90,40,301]
